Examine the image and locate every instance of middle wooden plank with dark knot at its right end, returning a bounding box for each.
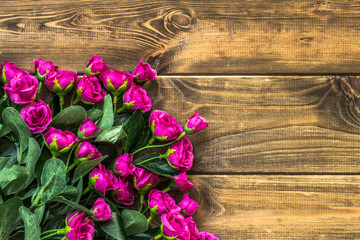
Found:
[145,76,360,173]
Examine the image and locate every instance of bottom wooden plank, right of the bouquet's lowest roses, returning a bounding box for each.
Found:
[190,175,360,240]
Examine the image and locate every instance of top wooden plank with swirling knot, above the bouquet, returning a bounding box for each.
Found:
[0,0,360,75]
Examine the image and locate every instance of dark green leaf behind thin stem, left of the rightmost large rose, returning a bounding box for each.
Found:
[132,153,180,177]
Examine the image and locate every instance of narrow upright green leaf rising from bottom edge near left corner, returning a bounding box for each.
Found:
[19,206,41,240]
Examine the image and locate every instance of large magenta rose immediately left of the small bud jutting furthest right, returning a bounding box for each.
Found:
[149,110,183,141]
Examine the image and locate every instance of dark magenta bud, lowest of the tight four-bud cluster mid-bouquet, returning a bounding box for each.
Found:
[112,177,135,206]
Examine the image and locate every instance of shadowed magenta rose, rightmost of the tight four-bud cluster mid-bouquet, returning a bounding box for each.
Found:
[133,168,160,194]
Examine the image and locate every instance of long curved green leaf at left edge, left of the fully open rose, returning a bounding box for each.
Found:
[2,107,31,153]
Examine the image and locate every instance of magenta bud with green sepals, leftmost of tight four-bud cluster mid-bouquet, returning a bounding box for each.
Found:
[89,163,116,195]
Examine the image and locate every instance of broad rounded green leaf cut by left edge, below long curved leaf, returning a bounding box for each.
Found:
[0,165,29,195]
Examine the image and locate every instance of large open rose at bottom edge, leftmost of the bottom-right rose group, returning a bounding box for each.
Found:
[161,211,190,240]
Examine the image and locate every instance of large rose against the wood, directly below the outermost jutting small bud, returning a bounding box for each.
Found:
[165,137,194,171]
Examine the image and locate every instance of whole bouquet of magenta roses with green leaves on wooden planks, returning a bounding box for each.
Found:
[0,56,218,240]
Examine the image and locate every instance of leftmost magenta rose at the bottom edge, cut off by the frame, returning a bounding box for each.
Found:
[66,210,95,240]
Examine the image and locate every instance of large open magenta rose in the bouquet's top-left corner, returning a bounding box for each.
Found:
[4,75,39,104]
